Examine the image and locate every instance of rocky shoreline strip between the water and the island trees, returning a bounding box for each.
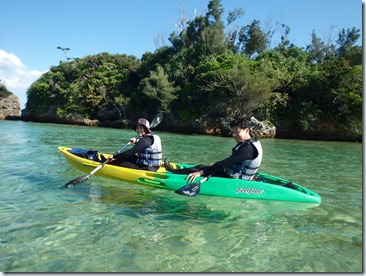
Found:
[0,95,362,142]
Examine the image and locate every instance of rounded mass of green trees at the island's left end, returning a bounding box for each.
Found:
[26,53,139,118]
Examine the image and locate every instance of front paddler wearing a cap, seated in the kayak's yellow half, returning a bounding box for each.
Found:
[102,118,163,171]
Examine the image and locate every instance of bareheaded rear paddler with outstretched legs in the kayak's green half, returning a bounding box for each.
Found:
[164,118,263,182]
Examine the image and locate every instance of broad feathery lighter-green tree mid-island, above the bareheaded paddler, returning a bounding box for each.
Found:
[178,54,273,119]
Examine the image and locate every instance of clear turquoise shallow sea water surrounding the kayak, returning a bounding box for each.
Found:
[0,121,363,272]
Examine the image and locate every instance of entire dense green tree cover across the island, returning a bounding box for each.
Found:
[23,0,362,140]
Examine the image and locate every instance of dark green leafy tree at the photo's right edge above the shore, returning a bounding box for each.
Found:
[297,58,362,135]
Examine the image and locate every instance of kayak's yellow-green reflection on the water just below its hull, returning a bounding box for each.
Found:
[62,180,319,223]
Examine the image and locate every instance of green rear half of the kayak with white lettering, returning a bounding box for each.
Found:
[137,164,321,203]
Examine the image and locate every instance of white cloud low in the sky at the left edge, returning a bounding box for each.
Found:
[0,49,44,107]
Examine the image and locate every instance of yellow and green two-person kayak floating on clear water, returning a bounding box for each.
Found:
[58,146,321,203]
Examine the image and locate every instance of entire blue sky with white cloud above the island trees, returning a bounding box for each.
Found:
[0,0,362,108]
